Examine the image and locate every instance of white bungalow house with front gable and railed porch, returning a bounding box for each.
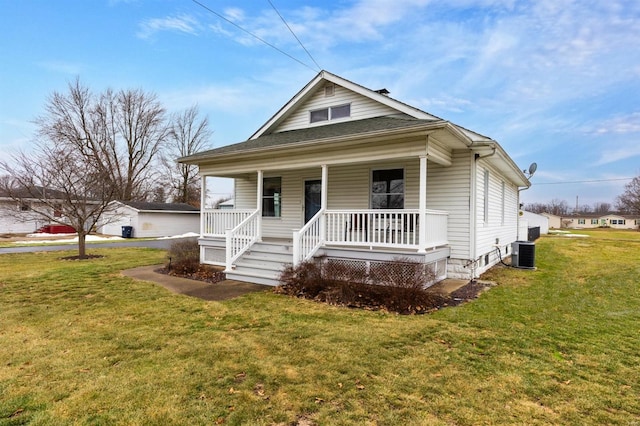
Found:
[179,71,530,285]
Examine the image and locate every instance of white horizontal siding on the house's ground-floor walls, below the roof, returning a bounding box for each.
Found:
[230,150,500,259]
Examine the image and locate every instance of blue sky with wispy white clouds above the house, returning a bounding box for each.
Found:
[0,0,640,205]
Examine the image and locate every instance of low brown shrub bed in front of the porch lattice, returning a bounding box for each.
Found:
[276,259,449,314]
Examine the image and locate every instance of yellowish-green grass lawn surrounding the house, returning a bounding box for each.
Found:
[0,234,640,425]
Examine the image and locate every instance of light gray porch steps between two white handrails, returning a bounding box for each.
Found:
[226,242,293,286]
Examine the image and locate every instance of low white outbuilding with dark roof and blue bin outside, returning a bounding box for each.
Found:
[98,201,200,238]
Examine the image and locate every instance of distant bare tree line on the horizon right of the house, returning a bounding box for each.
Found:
[525,180,640,216]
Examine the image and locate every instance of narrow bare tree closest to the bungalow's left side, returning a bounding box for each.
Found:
[162,105,213,206]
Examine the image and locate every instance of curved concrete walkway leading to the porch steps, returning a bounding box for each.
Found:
[122,265,273,301]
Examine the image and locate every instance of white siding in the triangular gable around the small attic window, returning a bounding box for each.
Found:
[274,85,398,133]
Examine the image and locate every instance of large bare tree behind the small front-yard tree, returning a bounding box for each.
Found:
[36,79,167,201]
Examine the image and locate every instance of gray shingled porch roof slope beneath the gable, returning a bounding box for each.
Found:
[178,116,440,161]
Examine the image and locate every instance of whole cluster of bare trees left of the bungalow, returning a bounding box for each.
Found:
[0,78,212,258]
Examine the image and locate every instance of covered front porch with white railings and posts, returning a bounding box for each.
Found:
[200,155,449,286]
